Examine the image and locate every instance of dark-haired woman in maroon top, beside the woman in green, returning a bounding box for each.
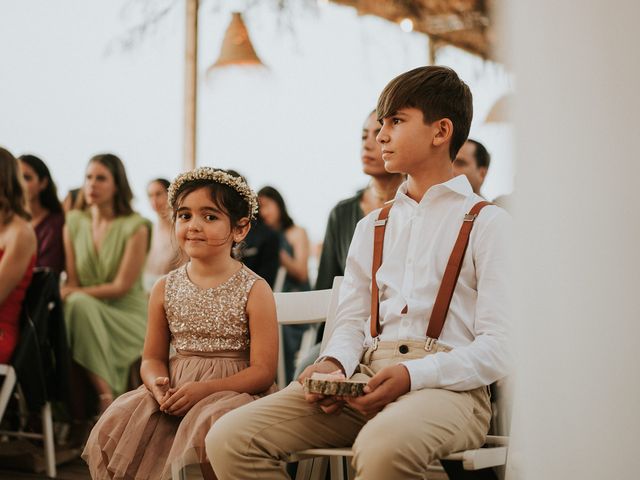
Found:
[18,155,64,274]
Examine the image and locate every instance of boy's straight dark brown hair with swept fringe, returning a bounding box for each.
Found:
[377,66,473,161]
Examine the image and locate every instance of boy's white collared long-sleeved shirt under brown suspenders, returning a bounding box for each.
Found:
[322,175,511,391]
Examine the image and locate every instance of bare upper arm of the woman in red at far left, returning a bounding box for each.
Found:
[0,222,37,304]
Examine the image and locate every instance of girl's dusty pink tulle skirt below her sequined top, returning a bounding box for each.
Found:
[82,352,276,480]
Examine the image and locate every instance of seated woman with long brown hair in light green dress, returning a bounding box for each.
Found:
[61,154,151,419]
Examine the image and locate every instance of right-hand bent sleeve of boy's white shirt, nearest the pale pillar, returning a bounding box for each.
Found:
[403,209,512,391]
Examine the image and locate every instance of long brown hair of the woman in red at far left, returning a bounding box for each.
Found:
[0,147,31,225]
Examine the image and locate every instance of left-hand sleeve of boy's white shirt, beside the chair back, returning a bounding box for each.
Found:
[321,216,373,377]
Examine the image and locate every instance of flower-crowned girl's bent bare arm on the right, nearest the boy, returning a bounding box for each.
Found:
[160,280,278,416]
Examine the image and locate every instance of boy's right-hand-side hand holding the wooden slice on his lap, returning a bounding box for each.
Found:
[344,364,411,418]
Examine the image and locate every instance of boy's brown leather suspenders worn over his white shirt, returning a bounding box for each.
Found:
[371,201,491,350]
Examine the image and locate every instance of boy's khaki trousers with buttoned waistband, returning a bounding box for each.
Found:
[206,341,491,480]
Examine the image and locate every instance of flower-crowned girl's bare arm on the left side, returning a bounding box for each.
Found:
[140,277,170,403]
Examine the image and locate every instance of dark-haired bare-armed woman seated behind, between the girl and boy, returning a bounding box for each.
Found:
[258,187,311,382]
